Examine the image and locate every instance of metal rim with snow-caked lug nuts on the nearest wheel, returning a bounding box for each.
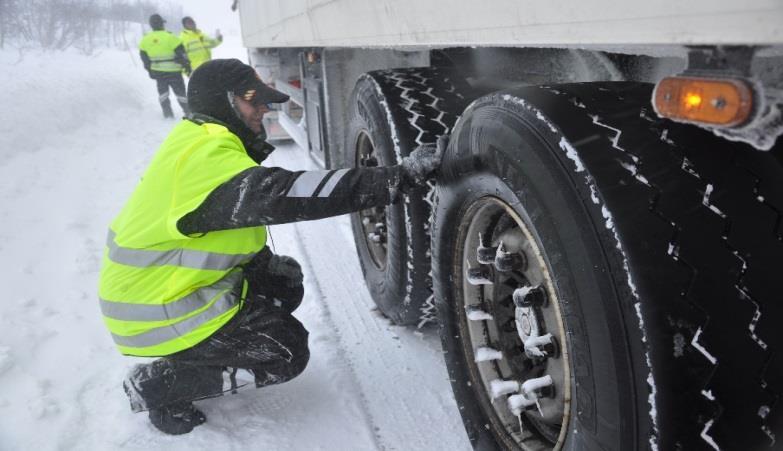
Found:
[455,197,571,450]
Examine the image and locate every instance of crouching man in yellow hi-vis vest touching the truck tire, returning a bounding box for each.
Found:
[99,59,446,434]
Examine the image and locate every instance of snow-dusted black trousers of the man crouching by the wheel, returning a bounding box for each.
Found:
[125,295,310,412]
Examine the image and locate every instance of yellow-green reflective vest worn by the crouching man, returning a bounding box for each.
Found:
[99,120,266,356]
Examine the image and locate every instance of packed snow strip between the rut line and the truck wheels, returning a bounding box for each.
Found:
[294,219,470,450]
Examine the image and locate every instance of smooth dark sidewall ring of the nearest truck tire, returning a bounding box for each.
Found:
[433,100,649,450]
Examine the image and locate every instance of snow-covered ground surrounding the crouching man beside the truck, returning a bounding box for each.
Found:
[0,40,470,451]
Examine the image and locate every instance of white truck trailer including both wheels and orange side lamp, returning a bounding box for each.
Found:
[239,0,783,450]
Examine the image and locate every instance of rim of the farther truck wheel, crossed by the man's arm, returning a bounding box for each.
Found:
[354,131,388,271]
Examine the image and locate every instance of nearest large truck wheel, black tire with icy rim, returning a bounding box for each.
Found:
[432,83,783,450]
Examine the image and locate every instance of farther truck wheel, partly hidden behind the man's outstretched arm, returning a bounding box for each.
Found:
[346,67,478,325]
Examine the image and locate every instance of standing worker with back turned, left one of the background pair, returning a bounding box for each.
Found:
[139,14,190,117]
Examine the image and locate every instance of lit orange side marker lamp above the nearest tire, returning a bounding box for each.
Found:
[653,77,753,127]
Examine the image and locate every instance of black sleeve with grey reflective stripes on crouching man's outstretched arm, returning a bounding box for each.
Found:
[177,166,410,235]
